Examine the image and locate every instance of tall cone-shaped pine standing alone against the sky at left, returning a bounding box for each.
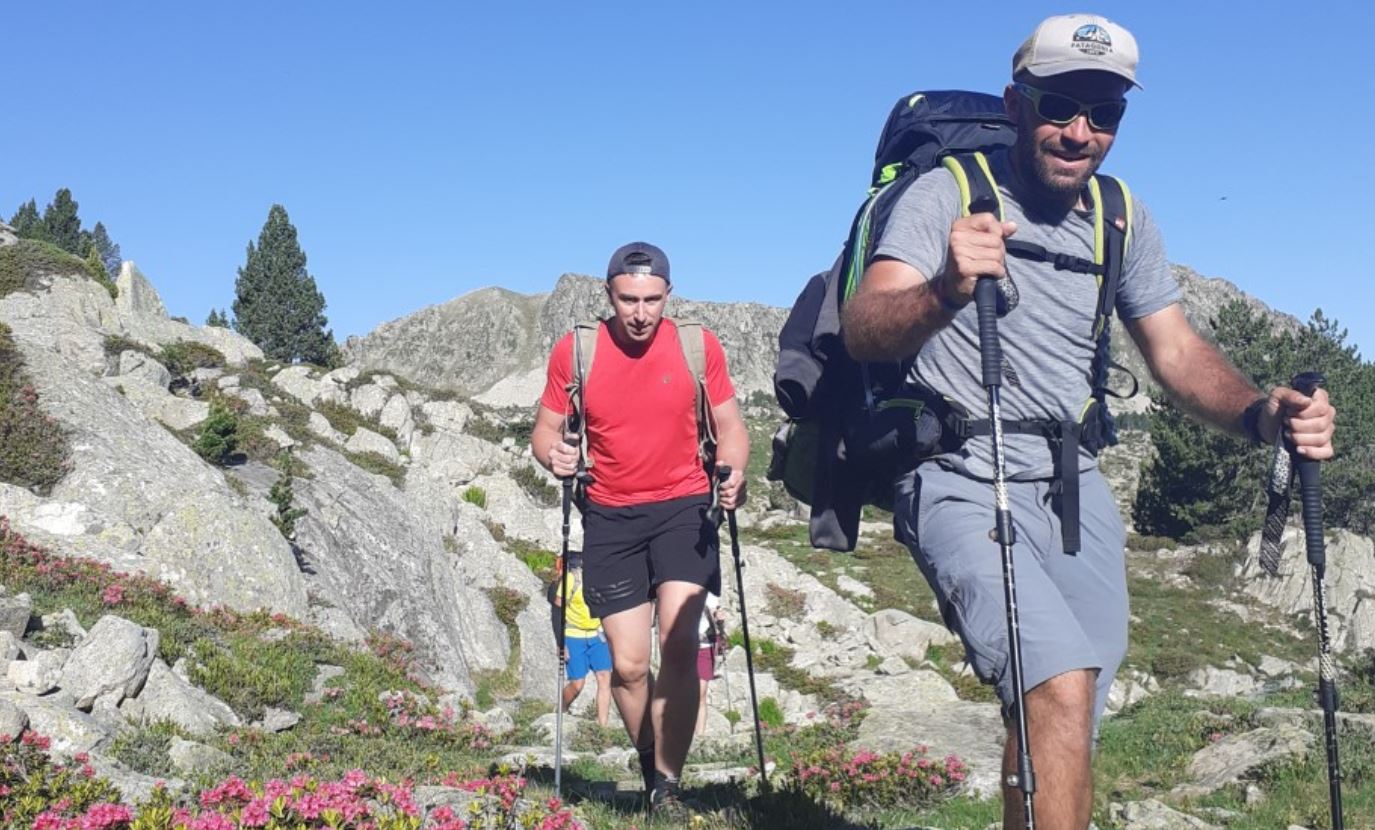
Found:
[234,205,338,366]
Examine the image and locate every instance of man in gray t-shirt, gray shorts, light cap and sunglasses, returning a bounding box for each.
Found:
[843,14,1334,830]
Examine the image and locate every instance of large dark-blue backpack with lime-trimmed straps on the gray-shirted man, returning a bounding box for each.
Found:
[769,91,1134,551]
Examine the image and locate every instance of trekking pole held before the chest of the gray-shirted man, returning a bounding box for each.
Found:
[969,234,1035,830]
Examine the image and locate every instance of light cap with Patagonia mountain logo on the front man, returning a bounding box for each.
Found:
[1012,14,1141,87]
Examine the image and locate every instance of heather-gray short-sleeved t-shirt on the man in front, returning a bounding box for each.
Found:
[873,153,1181,480]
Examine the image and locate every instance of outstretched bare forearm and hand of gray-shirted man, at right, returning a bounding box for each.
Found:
[1126,304,1337,459]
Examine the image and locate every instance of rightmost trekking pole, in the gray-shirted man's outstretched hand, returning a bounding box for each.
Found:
[1280,372,1343,830]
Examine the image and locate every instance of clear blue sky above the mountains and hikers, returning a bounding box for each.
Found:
[0,0,1375,359]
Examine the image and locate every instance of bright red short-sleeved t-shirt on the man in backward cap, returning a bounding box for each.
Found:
[539,317,736,507]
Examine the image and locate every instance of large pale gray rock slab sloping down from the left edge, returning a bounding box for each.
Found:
[0,270,305,616]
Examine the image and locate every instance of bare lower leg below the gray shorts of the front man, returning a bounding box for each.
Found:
[1002,669,1097,830]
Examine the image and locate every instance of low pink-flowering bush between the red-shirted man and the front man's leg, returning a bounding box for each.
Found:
[789,745,967,808]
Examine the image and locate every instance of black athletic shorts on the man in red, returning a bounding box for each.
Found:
[583,493,721,617]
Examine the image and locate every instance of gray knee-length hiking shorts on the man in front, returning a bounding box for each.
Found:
[894,463,1128,724]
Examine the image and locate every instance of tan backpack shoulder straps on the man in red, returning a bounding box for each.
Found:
[564,320,716,507]
